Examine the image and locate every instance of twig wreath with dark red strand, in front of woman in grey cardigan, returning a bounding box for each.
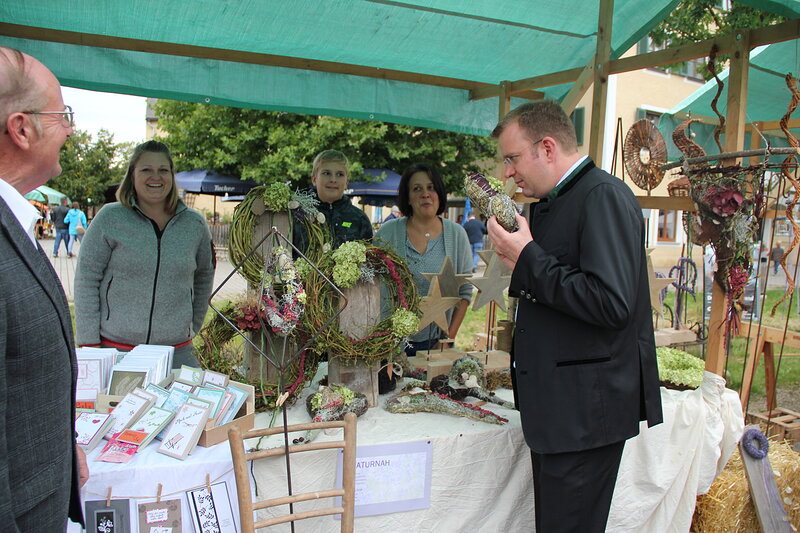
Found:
[297,241,419,365]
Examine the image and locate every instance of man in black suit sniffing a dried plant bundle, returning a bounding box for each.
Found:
[488,101,662,533]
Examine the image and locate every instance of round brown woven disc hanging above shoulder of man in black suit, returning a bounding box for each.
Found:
[622,119,667,191]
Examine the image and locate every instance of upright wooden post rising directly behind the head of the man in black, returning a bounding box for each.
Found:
[589,0,614,167]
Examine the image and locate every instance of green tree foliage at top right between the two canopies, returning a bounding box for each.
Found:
[650,0,786,80]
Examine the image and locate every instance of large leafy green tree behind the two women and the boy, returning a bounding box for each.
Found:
[155,100,495,192]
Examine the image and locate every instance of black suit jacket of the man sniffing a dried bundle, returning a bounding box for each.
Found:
[509,160,662,453]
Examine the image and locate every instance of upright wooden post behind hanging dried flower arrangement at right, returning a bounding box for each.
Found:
[706,31,750,376]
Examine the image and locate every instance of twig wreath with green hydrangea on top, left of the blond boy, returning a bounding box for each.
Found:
[228,183,331,286]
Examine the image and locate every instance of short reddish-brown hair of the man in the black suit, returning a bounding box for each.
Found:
[492,100,578,151]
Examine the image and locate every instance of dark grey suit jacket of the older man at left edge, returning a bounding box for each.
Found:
[0,194,82,532]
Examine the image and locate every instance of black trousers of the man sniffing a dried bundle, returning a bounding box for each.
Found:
[531,441,625,533]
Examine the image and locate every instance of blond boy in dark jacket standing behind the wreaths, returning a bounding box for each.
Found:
[293,150,372,252]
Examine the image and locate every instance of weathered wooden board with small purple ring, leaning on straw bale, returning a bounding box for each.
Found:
[739,425,792,533]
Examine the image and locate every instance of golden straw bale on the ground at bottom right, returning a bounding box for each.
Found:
[692,440,800,533]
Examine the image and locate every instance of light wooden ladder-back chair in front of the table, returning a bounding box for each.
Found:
[228,413,356,533]
